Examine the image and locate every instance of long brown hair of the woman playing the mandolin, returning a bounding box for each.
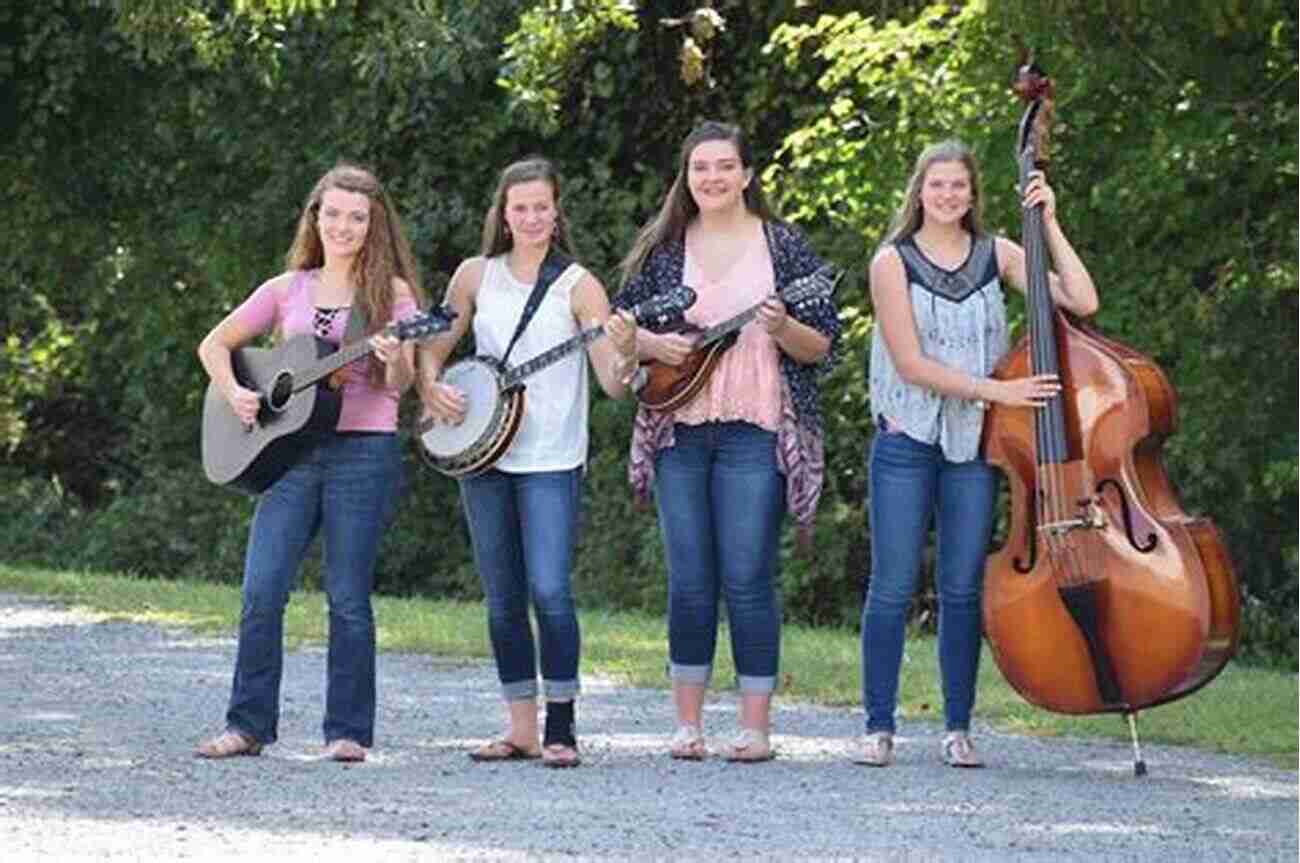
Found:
[619,120,775,285]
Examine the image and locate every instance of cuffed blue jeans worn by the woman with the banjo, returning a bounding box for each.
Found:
[460,468,582,702]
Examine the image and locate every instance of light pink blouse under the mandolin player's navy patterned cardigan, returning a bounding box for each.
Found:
[673,235,781,432]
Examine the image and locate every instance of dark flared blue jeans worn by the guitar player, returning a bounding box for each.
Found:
[226,434,402,746]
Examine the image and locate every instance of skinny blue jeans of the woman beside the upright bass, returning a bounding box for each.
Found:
[862,421,997,733]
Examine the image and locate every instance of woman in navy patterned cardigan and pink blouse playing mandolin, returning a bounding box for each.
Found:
[615,122,840,762]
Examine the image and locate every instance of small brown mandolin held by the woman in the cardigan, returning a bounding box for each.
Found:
[637,264,844,411]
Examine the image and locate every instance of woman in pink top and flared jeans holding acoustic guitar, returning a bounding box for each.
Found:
[198,165,419,762]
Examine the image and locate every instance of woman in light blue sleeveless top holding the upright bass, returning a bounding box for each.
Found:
[853,140,1097,767]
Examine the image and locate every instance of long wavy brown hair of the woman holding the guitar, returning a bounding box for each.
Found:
[285,162,424,361]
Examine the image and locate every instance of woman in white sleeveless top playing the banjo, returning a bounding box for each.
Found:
[420,159,636,767]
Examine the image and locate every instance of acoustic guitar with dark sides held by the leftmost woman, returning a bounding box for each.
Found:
[203,308,456,494]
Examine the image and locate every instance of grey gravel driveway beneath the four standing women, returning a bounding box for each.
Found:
[0,594,1297,863]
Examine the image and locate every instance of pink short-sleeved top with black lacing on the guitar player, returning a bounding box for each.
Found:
[234,270,419,432]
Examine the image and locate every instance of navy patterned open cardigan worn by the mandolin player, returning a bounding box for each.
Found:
[614,221,841,542]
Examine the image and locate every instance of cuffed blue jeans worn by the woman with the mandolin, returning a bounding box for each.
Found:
[655,422,785,695]
